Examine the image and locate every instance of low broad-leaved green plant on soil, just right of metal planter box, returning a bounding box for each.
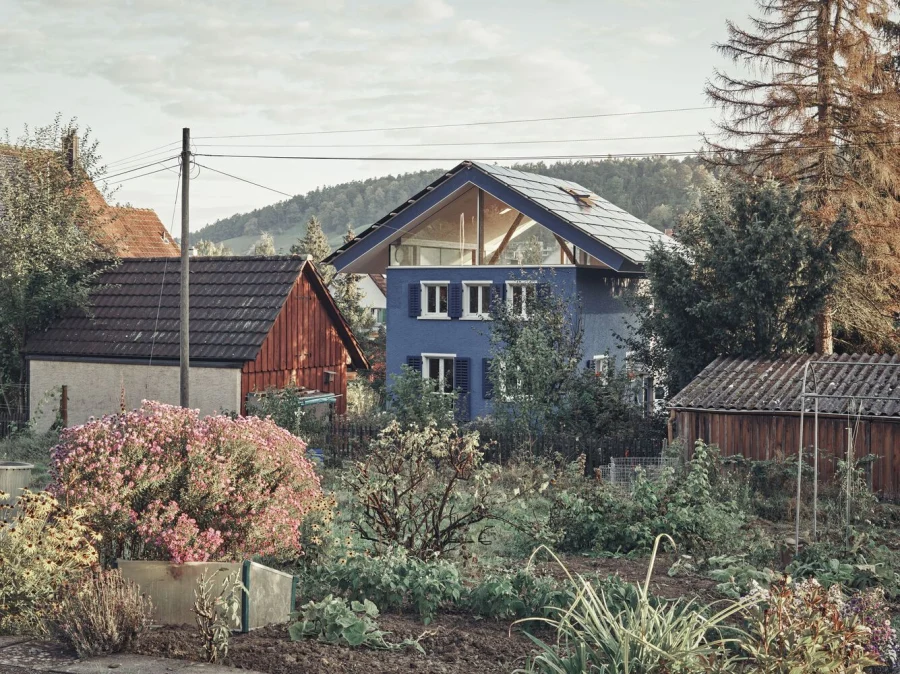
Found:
[288,595,425,653]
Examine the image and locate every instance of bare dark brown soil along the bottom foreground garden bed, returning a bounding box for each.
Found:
[135,614,535,674]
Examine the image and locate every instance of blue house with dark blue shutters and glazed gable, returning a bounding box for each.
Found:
[328,161,668,417]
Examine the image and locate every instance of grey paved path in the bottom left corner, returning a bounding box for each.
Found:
[0,637,264,674]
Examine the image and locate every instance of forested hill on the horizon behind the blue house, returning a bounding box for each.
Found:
[195,157,710,254]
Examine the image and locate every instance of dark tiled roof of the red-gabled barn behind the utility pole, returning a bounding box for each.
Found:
[27,256,368,368]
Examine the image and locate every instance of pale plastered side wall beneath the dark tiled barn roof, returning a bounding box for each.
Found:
[29,360,241,431]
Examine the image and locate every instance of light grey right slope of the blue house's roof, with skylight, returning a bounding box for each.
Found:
[472,162,667,264]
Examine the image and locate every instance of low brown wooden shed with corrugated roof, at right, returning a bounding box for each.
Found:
[669,354,900,497]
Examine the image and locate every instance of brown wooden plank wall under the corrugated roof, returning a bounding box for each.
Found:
[673,410,900,497]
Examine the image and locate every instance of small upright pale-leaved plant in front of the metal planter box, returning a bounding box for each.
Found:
[191,569,247,663]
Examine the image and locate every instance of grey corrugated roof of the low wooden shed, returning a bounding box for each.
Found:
[669,354,900,418]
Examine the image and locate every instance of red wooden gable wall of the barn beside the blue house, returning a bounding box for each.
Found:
[241,271,349,414]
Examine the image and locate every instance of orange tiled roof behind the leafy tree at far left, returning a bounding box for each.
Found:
[0,145,181,258]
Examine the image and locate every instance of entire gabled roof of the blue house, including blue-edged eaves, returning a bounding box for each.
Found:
[326,161,670,271]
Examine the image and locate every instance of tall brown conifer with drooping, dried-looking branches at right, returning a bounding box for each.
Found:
[706,0,900,353]
